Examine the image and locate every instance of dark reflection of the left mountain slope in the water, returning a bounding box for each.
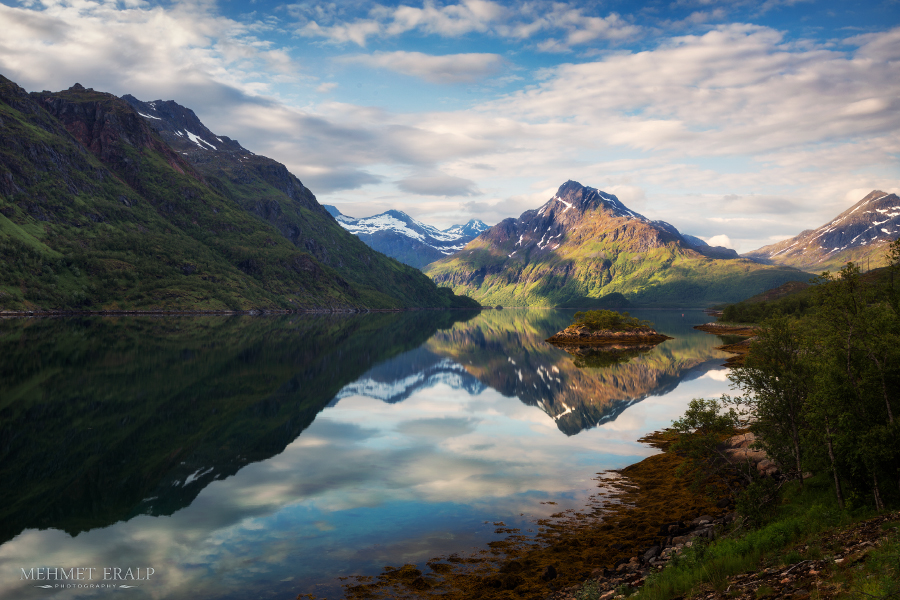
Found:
[0,311,474,543]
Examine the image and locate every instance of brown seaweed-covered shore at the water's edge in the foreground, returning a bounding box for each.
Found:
[344,432,734,600]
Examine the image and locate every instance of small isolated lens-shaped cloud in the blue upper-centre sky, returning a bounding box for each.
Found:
[340,51,504,83]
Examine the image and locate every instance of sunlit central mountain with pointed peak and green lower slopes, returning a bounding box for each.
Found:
[425,181,808,307]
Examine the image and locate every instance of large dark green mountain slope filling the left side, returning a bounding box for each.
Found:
[0,76,478,310]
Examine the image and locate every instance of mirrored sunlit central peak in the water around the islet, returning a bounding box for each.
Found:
[426,311,724,435]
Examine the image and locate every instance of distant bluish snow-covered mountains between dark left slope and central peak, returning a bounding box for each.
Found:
[325,205,488,269]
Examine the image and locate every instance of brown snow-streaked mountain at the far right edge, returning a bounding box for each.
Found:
[744,190,900,272]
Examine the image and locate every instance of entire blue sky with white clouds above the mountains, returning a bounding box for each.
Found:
[0,0,900,252]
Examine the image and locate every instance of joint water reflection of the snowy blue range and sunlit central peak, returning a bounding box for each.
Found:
[336,310,722,435]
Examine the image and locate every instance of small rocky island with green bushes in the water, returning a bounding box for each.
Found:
[547,310,672,346]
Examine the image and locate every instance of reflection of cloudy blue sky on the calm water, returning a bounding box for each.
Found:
[0,318,728,598]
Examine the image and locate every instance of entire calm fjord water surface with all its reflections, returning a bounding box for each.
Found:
[0,310,728,599]
